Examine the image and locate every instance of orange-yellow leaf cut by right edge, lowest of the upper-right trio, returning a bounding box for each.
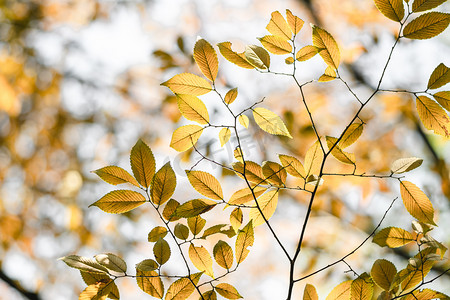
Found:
[416,96,450,137]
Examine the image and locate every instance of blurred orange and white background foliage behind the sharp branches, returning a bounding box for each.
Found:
[0,0,450,299]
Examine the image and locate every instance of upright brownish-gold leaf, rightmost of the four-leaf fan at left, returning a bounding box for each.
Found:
[150,162,177,205]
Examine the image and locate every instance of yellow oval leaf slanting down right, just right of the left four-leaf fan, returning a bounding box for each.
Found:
[186,171,223,200]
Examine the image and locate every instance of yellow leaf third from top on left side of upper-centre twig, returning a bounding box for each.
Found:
[177,94,209,124]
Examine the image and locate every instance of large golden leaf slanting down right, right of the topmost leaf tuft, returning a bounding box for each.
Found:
[312,25,340,69]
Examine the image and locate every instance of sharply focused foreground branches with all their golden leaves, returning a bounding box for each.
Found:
[62,0,450,300]
